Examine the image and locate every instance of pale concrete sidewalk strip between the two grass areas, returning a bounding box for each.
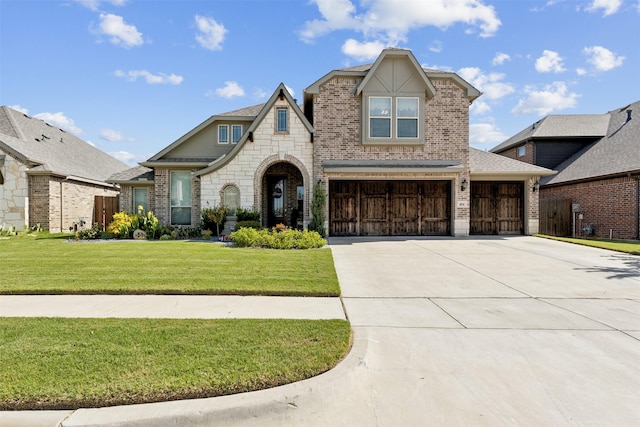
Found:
[0,295,346,320]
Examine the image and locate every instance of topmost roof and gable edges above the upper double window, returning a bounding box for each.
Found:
[304,48,482,101]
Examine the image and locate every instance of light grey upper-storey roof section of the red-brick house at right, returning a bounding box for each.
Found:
[489,114,610,153]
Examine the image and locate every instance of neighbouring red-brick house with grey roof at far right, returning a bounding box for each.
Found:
[491,101,640,239]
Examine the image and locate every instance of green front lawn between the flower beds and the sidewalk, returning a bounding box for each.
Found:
[0,237,340,296]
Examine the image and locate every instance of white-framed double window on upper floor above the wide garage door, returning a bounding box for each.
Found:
[367,96,422,144]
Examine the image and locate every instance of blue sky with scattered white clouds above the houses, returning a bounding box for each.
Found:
[0,0,640,165]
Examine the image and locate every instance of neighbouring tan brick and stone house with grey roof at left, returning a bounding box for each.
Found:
[0,107,128,232]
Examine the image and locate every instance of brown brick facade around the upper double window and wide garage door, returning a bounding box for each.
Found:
[313,76,470,234]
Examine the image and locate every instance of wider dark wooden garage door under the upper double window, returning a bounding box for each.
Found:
[329,181,451,236]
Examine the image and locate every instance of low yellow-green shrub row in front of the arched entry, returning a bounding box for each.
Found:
[231,227,327,249]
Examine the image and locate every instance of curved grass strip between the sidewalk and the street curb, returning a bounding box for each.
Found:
[0,318,350,410]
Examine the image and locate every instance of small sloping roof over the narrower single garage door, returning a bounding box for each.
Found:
[469,147,555,178]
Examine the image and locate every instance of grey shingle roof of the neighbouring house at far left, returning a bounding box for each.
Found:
[0,106,129,183]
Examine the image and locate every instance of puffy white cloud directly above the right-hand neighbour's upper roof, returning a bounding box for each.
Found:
[511,82,579,116]
